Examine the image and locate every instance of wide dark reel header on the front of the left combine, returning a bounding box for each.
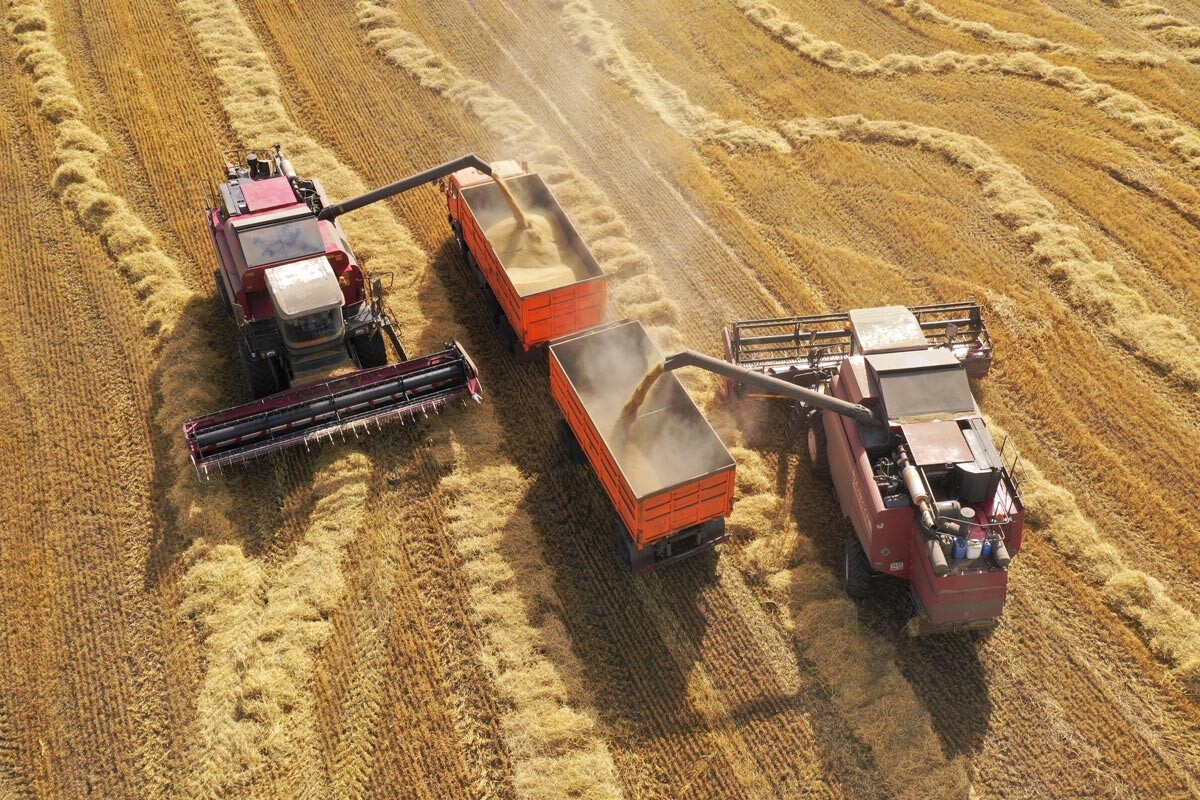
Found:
[184,342,482,476]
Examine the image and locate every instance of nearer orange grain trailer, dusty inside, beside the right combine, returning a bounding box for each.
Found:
[550,320,734,572]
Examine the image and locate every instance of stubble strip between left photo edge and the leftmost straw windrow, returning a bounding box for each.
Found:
[0,65,180,793]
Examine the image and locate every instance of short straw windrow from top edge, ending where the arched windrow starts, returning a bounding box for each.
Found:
[550,0,791,152]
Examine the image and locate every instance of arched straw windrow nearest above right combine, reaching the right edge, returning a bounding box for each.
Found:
[782,116,1200,387]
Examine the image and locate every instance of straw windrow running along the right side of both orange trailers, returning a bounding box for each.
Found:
[359,10,966,793]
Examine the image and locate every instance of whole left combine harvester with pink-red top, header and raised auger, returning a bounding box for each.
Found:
[184,145,491,475]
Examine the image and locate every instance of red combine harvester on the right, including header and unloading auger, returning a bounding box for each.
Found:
[666,303,1025,634]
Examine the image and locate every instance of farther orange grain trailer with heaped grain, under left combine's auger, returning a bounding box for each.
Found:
[442,161,605,359]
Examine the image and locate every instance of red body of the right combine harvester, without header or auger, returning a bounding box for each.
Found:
[809,350,1025,632]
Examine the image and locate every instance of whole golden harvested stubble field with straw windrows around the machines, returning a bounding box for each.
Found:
[0,0,1200,800]
